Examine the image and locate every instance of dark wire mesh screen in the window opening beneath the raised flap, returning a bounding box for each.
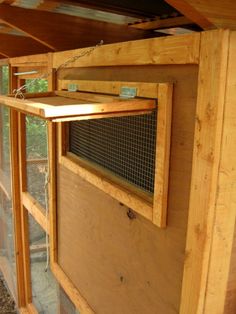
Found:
[69,111,157,193]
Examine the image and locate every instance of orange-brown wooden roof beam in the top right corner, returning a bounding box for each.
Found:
[165,0,236,30]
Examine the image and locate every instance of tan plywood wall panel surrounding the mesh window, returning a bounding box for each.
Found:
[58,66,197,314]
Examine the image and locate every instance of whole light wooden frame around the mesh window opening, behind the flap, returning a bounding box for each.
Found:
[58,81,173,228]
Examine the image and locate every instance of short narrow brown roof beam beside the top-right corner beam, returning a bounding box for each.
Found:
[130,16,193,30]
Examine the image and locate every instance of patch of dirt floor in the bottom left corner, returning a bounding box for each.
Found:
[0,273,17,314]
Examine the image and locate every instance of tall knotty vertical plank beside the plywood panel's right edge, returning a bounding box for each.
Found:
[180,30,229,314]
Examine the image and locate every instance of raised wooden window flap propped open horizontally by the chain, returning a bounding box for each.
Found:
[0,92,156,122]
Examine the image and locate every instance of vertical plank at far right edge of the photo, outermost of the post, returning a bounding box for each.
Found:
[209,31,236,314]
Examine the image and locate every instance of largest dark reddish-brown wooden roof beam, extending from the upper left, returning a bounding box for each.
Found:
[0,4,153,50]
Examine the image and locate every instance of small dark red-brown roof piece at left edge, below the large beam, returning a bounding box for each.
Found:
[0,33,49,57]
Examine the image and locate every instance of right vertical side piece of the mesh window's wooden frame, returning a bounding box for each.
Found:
[153,83,173,228]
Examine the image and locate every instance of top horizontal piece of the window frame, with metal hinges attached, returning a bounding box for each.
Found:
[58,79,158,98]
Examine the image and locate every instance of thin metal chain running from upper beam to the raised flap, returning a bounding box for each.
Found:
[13,40,103,99]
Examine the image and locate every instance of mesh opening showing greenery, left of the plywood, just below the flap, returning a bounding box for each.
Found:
[26,116,48,208]
